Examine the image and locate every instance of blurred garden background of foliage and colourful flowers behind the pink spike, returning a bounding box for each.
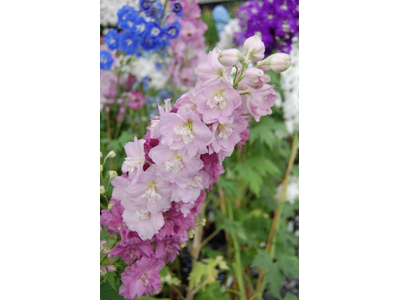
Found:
[100,0,299,300]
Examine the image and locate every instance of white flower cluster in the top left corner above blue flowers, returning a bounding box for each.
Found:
[100,0,139,26]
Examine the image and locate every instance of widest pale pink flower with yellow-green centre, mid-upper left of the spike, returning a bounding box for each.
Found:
[158,105,214,158]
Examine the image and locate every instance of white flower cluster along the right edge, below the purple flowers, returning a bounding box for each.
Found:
[281,39,299,134]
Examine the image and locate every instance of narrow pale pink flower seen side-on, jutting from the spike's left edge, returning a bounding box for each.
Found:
[121,136,146,182]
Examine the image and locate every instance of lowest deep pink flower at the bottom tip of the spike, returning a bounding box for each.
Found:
[119,257,165,299]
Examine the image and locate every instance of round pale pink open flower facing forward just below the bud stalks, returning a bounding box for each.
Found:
[196,80,241,124]
